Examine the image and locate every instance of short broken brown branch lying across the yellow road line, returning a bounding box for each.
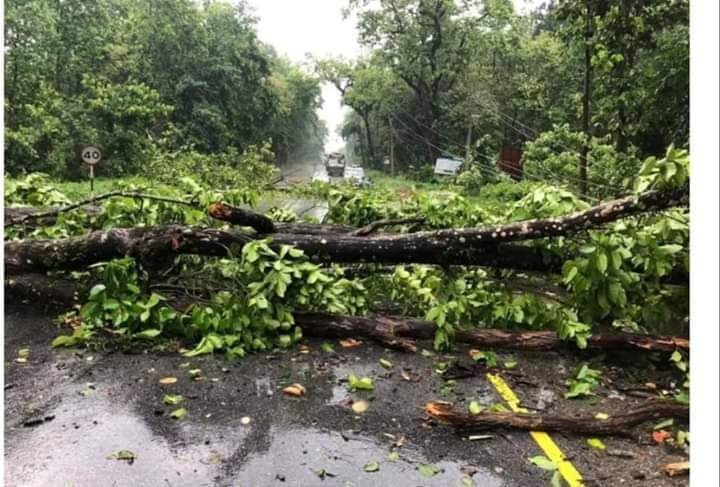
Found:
[425,400,690,436]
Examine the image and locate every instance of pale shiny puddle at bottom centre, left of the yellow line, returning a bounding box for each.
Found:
[234,429,503,487]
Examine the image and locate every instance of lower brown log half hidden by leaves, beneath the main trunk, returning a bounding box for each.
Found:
[5,274,690,352]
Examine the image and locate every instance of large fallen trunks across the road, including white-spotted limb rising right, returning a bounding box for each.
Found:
[5,190,687,274]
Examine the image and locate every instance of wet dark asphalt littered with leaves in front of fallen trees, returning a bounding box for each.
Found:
[5,306,688,487]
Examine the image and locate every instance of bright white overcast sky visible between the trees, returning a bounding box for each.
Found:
[248,0,540,151]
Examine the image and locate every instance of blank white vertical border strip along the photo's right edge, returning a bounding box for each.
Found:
[690,0,720,487]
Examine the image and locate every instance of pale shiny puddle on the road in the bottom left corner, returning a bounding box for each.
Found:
[5,400,240,487]
